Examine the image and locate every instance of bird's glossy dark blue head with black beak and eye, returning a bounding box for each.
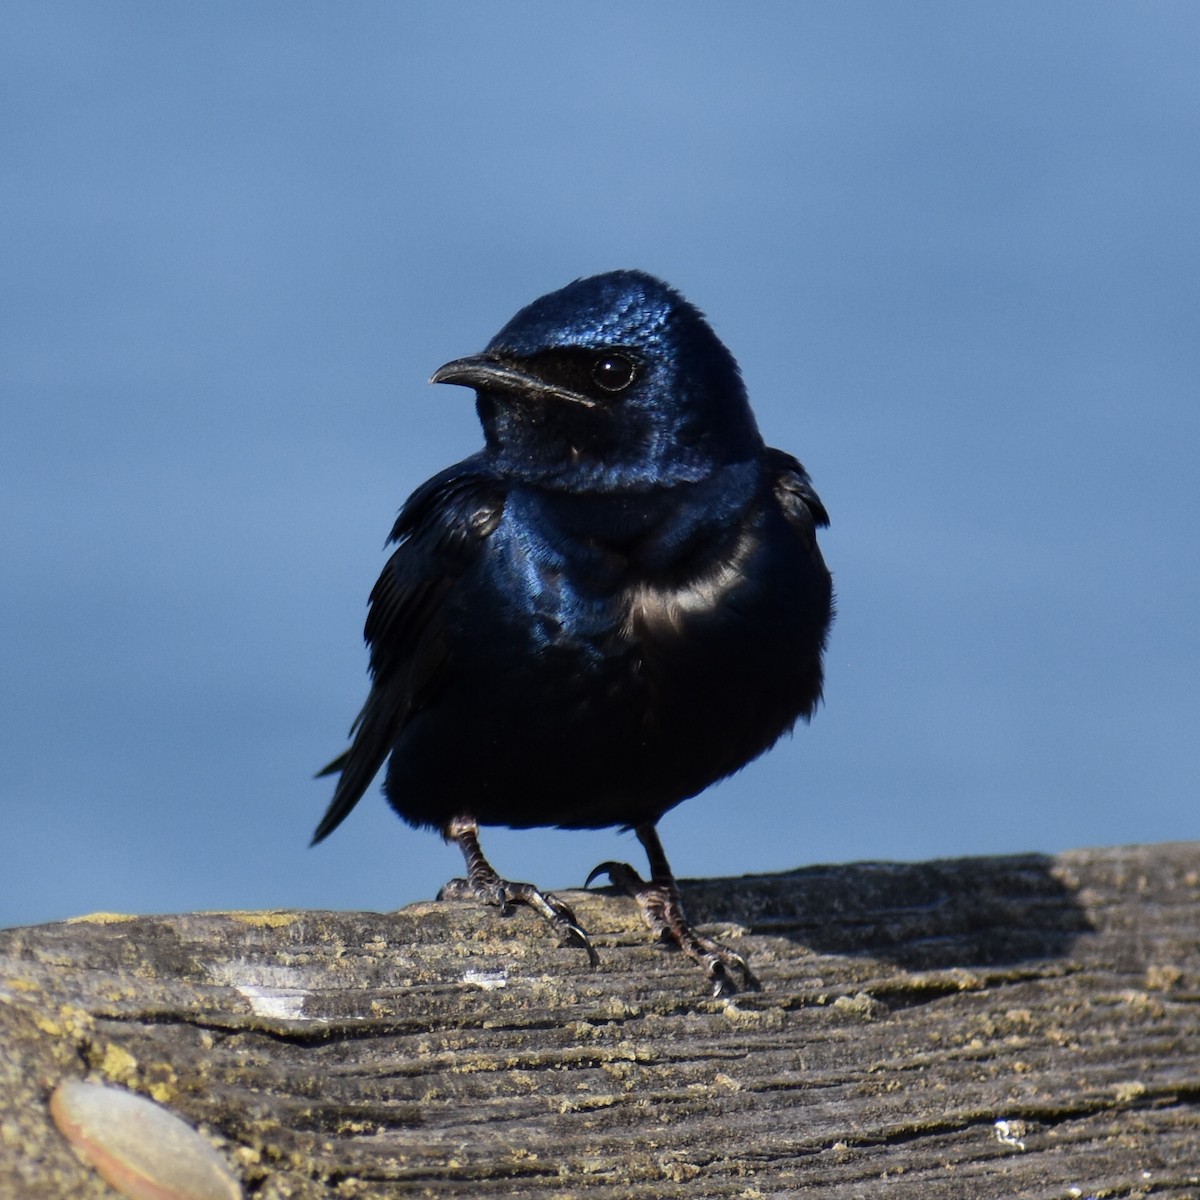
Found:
[432,271,762,491]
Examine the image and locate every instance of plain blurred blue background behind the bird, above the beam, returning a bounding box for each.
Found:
[0,0,1200,924]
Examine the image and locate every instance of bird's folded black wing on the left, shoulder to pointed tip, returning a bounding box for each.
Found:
[312,458,504,845]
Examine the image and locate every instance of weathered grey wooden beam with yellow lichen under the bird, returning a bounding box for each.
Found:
[0,844,1200,1200]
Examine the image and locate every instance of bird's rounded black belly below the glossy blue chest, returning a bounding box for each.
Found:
[386,564,820,828]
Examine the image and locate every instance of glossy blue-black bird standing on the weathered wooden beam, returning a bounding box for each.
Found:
[312,270,834,996]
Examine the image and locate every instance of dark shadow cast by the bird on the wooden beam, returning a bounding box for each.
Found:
[683,854,1092,970]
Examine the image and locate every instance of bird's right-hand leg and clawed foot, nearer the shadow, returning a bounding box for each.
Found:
[584,822,760,996]
